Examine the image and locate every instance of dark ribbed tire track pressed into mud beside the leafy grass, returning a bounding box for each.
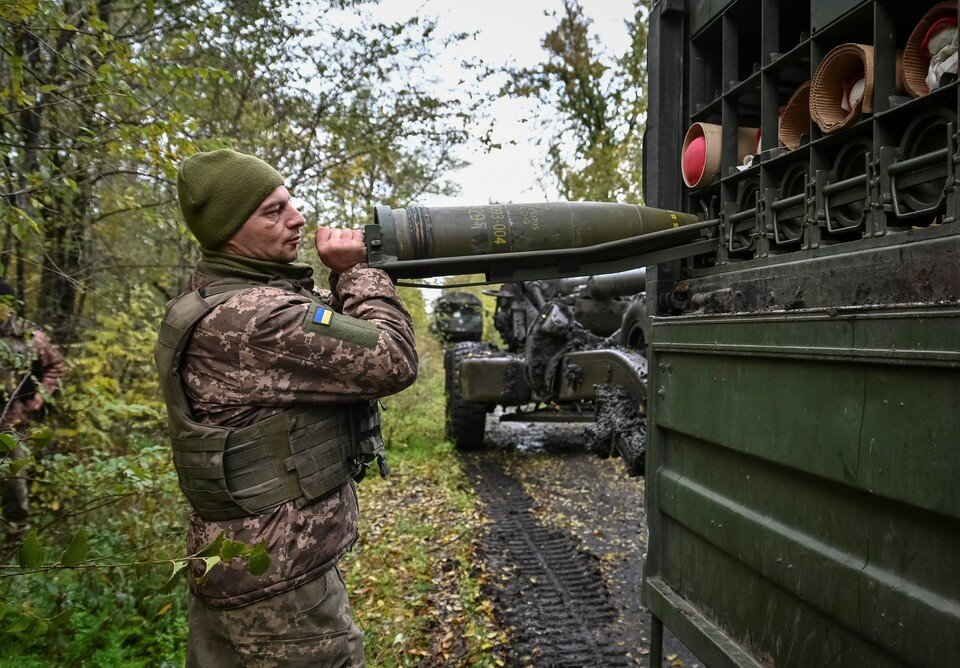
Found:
[464,455,636,666]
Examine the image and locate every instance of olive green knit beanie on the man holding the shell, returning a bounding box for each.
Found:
[177,149,283,250]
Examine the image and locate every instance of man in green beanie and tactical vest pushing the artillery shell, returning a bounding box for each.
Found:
[155,150,417,667]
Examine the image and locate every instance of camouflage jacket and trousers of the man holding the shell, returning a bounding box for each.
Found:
[181,260,417,666]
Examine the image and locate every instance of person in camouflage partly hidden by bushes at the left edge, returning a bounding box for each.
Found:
[0,281,64,534]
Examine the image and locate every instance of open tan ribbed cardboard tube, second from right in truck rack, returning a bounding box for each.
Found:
[810,44,903,132]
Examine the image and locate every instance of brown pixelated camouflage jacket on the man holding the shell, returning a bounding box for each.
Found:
[181,261,417,608]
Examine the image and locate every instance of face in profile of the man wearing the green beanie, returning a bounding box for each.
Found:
[221,186,305,262]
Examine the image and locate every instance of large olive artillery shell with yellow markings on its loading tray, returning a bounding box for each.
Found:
[364,202,716,283]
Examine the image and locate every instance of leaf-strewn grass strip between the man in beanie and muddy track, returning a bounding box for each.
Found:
[341,348,507,667]
